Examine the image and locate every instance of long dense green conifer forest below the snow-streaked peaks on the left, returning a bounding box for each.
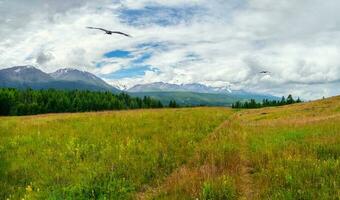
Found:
[0,88,163,116]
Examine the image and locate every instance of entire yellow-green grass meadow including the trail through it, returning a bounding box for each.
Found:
[0,97,340,199]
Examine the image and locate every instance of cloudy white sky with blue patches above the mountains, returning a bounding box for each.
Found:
[0,0,340,99]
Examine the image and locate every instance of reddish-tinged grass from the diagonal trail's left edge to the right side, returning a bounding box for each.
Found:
[139,97,340,199]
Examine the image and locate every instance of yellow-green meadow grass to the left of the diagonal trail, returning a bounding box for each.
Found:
[0,109,231,199]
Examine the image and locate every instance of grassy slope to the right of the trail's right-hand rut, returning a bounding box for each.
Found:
[244,97,340,199]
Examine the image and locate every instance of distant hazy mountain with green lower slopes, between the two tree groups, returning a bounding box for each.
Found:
[127,82,279,106]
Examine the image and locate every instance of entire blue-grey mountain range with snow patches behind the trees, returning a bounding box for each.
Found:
[0,66,278,106]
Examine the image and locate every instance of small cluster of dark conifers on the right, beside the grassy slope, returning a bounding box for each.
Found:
[232,95,302,108]
